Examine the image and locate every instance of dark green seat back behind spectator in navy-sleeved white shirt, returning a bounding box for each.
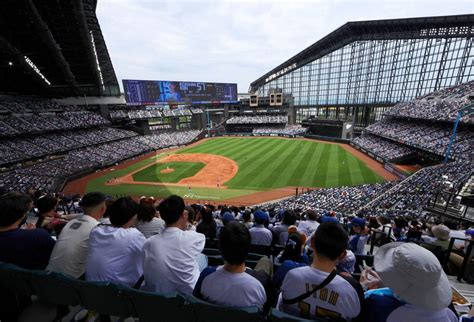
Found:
[183,296,264,322]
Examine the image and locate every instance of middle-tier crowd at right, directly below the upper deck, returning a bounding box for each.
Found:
[365,118,474,159]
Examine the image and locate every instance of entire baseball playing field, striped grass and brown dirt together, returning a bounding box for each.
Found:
[66,137,391,202]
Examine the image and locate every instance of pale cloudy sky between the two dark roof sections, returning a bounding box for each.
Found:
[97,0,474,92]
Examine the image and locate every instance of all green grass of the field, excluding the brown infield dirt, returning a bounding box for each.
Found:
[87,137,384,200]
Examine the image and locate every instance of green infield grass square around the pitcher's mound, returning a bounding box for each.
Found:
[133,162,205,183]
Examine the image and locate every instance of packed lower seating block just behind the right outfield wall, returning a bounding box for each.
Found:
[352,134,415,161]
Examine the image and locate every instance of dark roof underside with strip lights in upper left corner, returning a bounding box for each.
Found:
[0,0,120,97]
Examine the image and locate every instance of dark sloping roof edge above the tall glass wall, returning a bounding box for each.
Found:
[250,14,474,92]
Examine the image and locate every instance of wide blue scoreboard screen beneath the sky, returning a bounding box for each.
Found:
[123,79,238,105]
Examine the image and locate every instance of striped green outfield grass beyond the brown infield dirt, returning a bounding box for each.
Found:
[177,137,384,190]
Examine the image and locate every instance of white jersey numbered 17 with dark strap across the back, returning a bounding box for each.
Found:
[279,266,363,320]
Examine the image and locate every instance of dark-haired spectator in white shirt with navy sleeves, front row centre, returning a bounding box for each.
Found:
[193,221,276,311]
